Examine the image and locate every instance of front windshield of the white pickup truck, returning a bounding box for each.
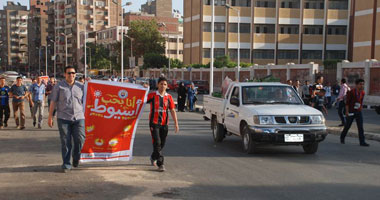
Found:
[242,86,303,104]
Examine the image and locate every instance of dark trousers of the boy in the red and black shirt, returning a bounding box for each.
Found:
[150,125,168,166]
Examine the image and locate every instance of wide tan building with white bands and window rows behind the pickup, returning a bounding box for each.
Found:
[184,0,350,64]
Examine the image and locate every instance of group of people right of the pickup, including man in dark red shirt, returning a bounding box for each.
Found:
[287,76,369,147]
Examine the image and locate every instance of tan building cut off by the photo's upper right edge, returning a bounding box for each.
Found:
[349,0,380,62]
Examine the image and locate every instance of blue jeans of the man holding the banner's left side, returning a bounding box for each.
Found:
[57,119,85,169]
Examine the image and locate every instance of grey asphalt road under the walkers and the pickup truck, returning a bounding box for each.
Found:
[0,105,380,200]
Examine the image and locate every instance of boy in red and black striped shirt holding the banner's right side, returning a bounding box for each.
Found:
[147,77,179,172]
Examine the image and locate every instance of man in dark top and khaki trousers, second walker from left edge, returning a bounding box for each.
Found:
[10,76,29,130]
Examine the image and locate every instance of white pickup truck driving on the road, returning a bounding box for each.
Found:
[203,83,327,154]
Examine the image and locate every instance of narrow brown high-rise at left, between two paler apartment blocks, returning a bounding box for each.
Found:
[28,0,52,72]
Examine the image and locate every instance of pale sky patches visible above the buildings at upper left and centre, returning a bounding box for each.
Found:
[0,0,183,15]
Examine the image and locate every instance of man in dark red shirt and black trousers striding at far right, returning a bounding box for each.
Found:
[340,79,369,147]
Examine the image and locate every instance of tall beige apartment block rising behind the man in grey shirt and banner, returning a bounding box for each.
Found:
[54,0,121,72]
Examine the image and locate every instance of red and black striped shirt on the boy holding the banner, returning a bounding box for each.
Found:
[147,91,175,126]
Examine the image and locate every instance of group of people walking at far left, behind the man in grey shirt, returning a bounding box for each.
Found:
[0,76,55,130]
